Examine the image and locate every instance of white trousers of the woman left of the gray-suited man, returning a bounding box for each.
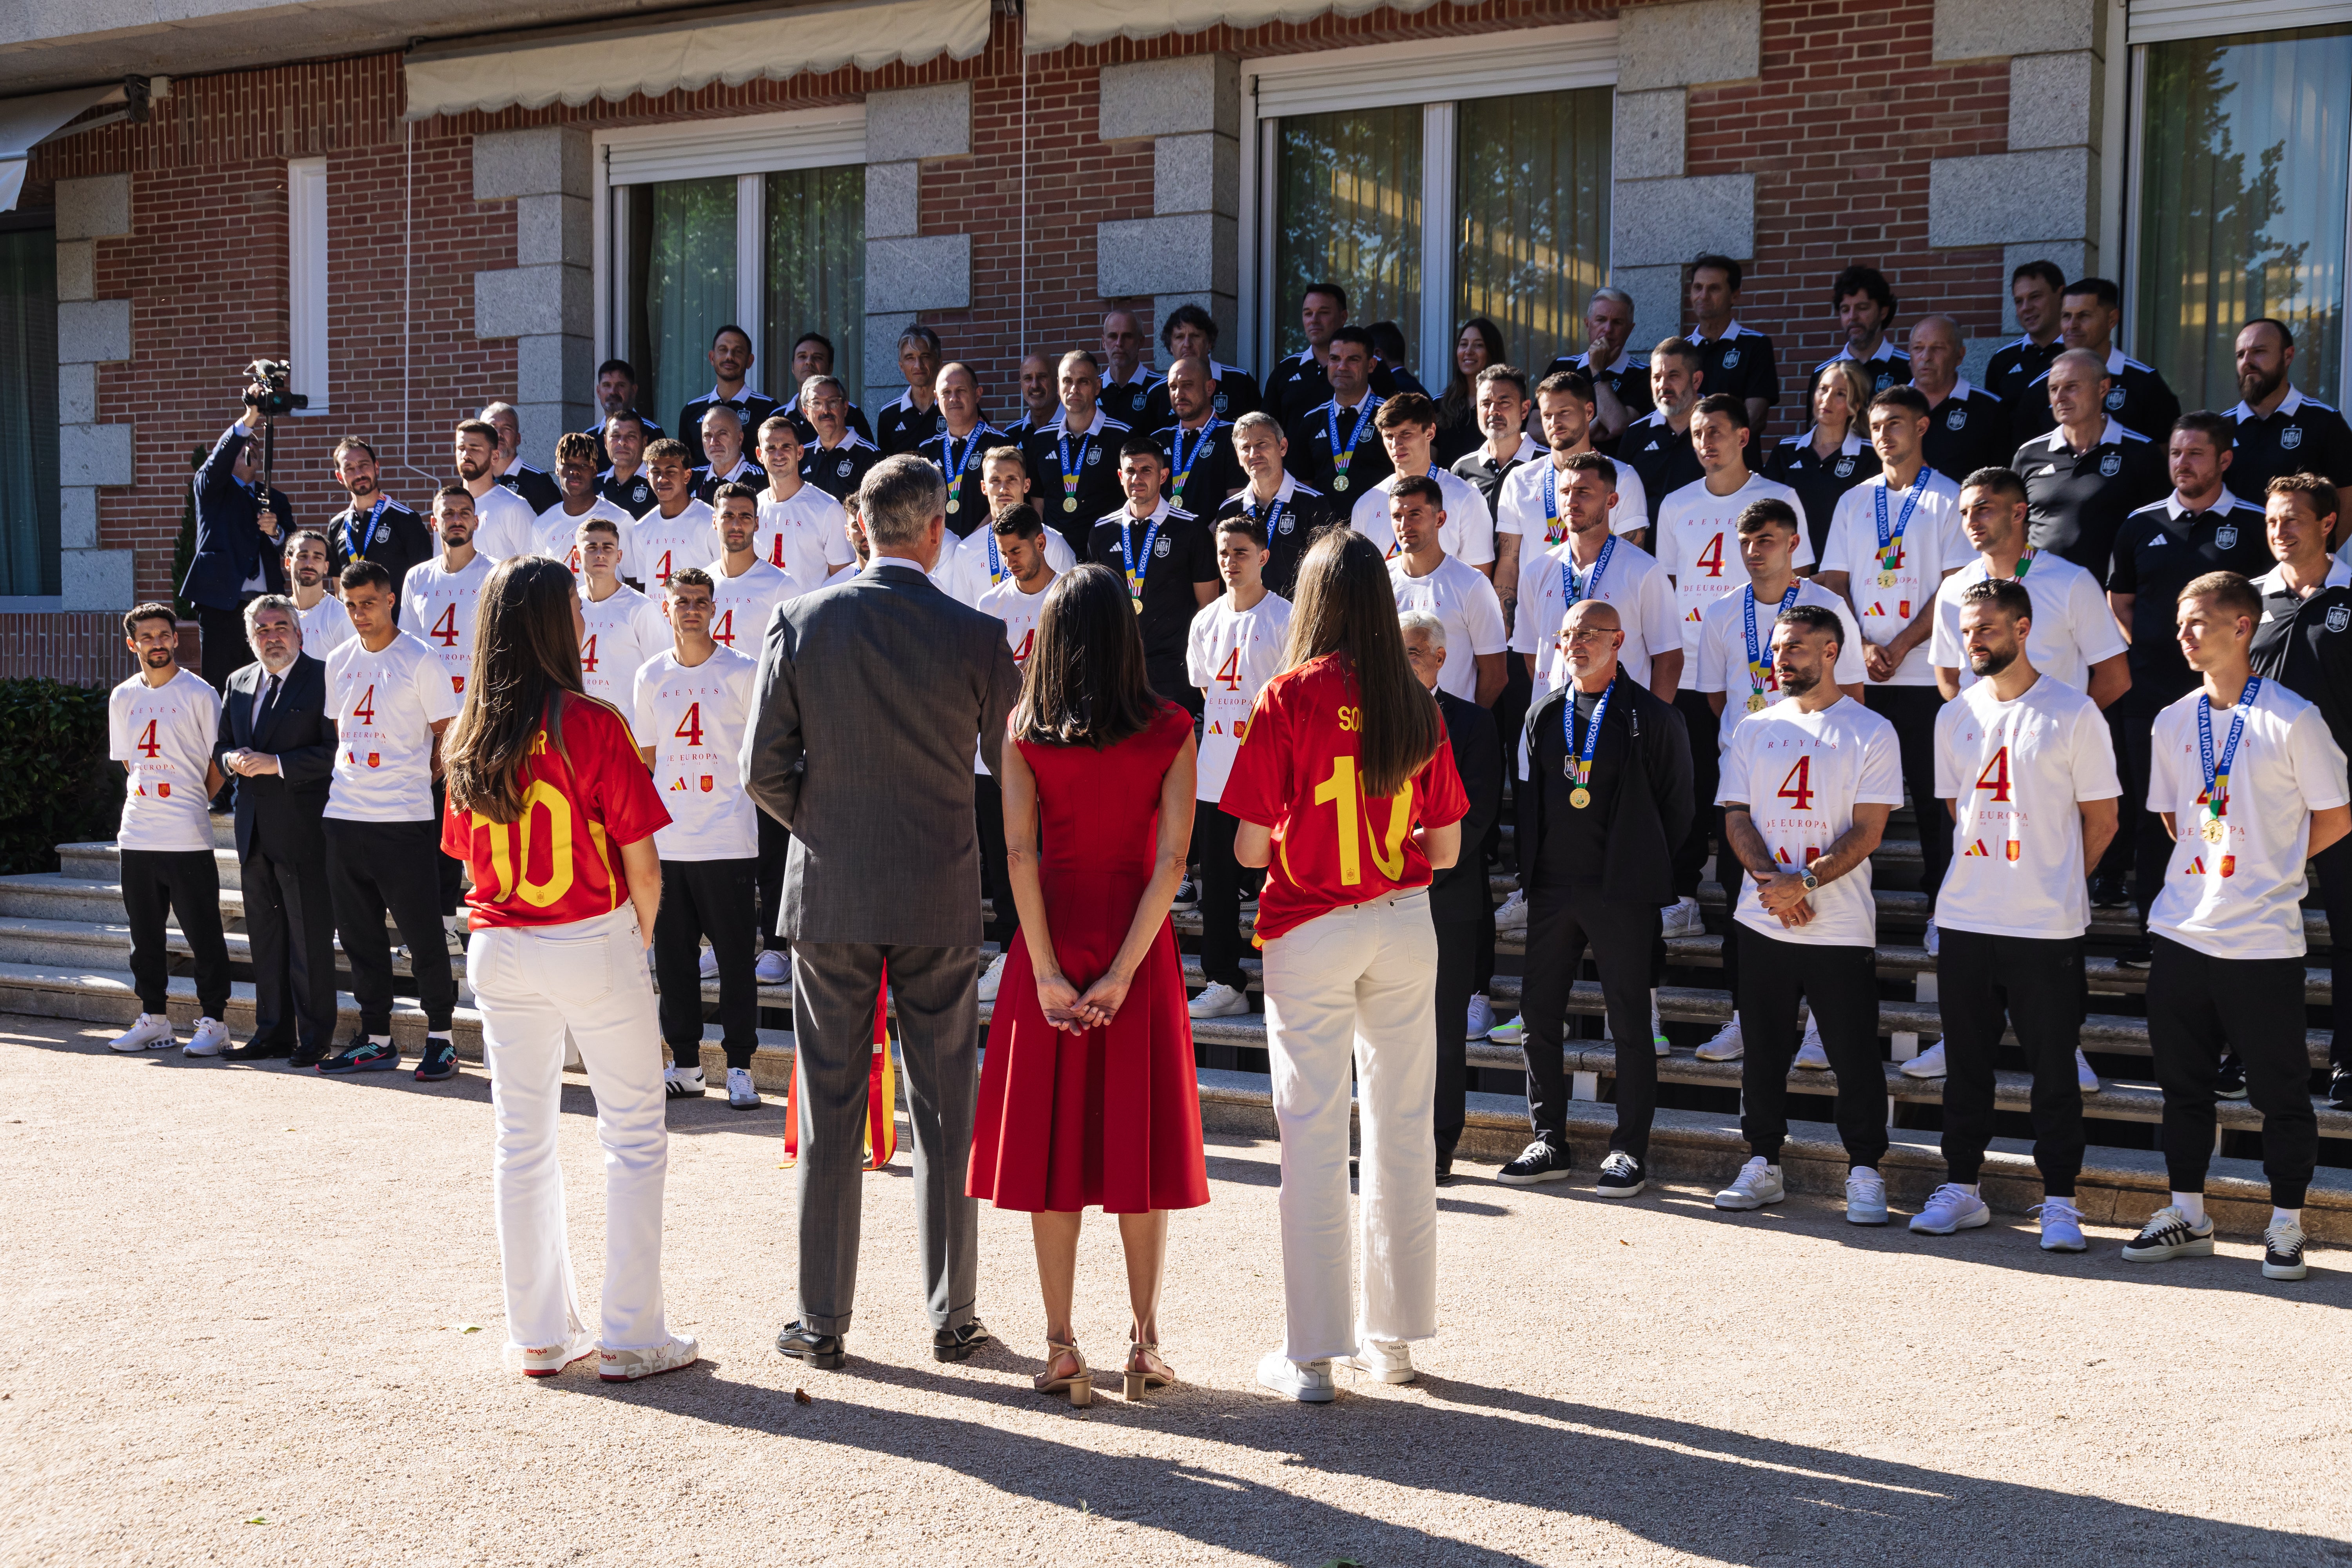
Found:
[466,905,670,1349]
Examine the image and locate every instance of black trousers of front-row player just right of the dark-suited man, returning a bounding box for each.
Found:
[327,816,456,1034]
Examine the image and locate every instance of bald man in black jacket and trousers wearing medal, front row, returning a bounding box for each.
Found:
[1505,599,1696,1196]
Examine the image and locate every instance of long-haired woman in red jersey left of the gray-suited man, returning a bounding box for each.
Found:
[442,555,696,1382]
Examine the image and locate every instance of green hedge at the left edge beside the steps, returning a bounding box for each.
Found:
[0,679,122,875]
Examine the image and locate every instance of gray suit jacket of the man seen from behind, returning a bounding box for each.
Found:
[743,559,1021,947]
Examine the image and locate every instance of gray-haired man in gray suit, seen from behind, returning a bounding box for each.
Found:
[743,456,1021,1368]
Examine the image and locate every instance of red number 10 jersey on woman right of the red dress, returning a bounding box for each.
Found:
[1218,653,1470,947]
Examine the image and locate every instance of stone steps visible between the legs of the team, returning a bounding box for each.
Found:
[0,813,2352,1239]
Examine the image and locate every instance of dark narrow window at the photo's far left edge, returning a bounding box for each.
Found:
[0,228,59,597]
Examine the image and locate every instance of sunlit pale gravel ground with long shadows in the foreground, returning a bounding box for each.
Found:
[0,1016,2352,1568]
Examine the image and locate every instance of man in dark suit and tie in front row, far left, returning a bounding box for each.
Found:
[212,595,334,1067]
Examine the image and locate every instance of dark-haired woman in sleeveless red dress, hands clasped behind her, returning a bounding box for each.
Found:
[969,566,1209,1403]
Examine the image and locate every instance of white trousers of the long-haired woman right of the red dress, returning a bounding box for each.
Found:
[1265,889,1437,1361]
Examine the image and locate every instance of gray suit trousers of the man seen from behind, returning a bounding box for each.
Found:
[793,940,981,1333]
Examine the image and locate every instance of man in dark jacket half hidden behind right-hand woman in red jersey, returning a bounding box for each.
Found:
[1397,609,1503,1180]
